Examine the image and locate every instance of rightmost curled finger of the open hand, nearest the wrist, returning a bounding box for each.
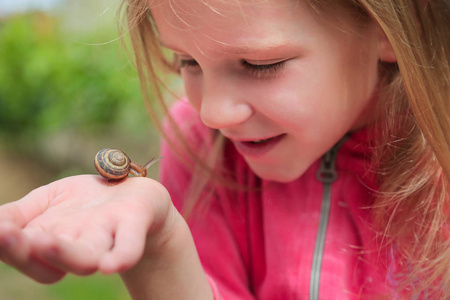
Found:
[99,218,148,274]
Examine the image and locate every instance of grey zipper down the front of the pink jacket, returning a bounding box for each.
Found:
[309,136,347,300]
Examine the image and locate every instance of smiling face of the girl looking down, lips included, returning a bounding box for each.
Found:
[151,0,392,182]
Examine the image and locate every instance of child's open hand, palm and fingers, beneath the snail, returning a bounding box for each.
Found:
[0,175,172,283]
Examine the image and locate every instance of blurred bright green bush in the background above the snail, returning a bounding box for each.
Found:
[0,13,151,143]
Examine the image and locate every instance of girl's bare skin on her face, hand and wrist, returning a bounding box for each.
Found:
[0,0,395,300]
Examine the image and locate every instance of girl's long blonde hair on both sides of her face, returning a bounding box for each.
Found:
[118,0,450,299]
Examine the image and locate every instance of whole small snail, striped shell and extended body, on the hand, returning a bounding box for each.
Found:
[94,148,162,181]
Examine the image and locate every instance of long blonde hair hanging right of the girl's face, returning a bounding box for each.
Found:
[360,0,450,299]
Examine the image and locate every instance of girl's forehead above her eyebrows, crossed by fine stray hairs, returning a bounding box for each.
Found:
[150,0,303,51]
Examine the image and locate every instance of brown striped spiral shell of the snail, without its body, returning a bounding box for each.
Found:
[94,148,131,180]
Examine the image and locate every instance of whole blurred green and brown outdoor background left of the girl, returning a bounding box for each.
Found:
[0,0,176,300]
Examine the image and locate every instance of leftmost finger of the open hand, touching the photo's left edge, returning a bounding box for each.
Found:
[0,224,65,284]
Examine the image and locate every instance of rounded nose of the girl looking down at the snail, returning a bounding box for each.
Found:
[200,76,253,129]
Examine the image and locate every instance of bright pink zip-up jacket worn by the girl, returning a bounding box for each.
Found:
[160,101,389,300]
